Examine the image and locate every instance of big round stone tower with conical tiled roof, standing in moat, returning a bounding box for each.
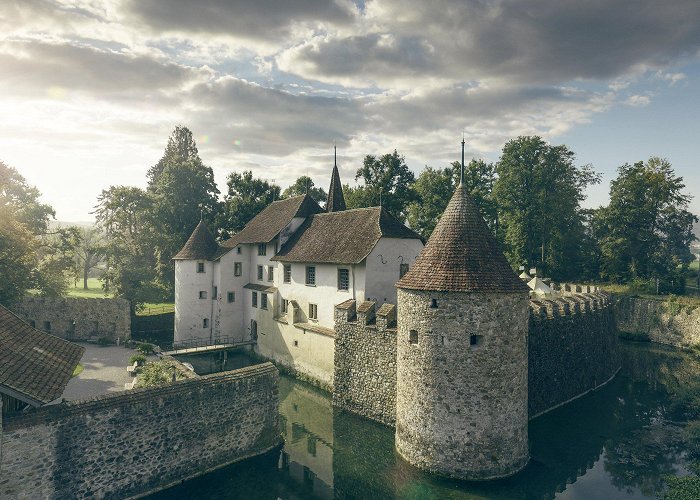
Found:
[396,184,529,480]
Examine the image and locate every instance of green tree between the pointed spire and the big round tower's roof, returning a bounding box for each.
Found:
[352,150,418,221]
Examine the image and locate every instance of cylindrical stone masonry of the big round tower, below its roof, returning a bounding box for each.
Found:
[396,288,529,480]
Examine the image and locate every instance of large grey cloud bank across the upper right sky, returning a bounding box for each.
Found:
[278,0,700,87]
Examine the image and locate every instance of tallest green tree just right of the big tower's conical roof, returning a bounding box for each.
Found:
[493,136,600,280]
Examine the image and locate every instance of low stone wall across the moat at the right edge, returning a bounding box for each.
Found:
[615,297,700,347]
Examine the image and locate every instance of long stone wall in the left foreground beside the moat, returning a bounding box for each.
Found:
[0,363,281,499]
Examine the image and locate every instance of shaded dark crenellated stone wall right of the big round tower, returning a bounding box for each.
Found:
[528,292,620,418]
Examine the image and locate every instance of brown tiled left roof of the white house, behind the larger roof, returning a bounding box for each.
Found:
[222,194,323,248]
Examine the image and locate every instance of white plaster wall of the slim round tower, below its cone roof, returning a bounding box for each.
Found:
[175,260,214,343]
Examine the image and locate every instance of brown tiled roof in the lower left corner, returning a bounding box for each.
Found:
[0,306,85,406]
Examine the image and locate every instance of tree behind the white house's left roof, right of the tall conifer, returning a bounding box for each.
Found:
[218,170,280,238]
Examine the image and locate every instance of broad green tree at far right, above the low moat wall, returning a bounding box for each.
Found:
[596,157,698,288]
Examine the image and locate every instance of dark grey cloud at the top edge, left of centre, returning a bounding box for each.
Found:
[127,0,354,40]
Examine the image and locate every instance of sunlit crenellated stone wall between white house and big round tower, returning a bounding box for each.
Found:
[333,300,396,425]
